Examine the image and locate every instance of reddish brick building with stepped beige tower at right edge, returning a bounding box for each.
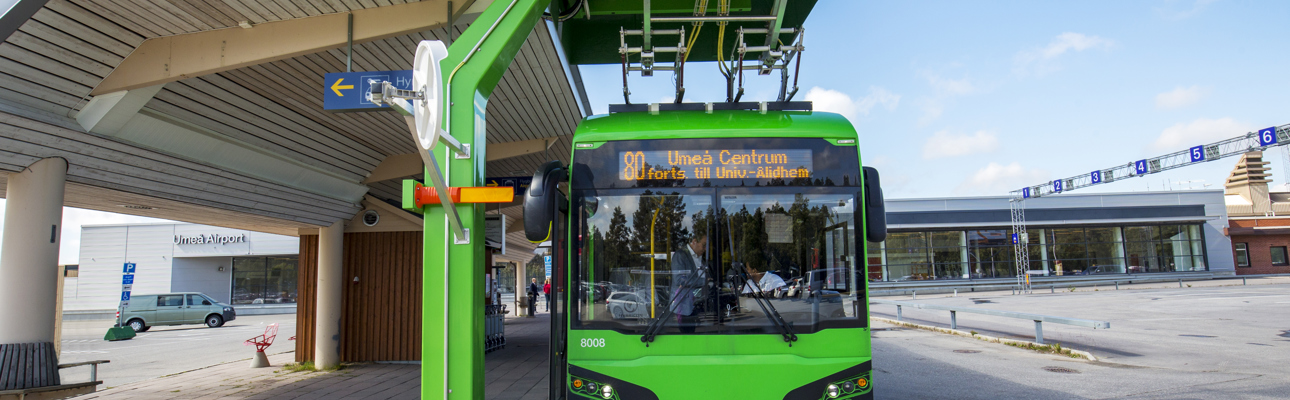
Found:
[1224,151,1290,275]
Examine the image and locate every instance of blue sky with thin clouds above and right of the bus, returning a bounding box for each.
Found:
[581,0,1290,199]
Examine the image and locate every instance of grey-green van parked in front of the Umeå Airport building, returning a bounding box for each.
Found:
[120,293,237,332]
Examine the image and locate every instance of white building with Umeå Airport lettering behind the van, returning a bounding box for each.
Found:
[63,223,301,315]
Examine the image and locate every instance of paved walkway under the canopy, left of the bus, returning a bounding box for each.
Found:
[76,314,551,400]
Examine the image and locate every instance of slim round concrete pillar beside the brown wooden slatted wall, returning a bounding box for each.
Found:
[313,221,344,369]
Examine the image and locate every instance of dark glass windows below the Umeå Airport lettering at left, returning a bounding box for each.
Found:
[232,255,299,305]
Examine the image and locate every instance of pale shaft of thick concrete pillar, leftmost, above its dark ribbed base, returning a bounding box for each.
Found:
[0,157,67,343]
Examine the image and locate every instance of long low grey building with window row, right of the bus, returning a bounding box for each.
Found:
[867,191,1236,281]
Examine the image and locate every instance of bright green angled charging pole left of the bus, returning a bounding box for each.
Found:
[417,0,548,399]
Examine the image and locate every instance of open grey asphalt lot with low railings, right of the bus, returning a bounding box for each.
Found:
[873,284,1290,399]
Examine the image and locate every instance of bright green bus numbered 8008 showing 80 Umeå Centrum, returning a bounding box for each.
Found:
[524,103,886,400]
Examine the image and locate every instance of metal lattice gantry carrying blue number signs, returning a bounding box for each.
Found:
[1009,124,1290,293]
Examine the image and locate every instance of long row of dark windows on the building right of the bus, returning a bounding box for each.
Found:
[868,223,1207,281]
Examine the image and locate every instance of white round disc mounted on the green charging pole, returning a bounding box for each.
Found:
[412,40,448,151]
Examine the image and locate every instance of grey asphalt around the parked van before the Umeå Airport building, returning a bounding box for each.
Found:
[58,314,295,387]
